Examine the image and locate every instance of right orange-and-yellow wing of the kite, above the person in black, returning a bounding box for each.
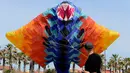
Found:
[80,17,119,54]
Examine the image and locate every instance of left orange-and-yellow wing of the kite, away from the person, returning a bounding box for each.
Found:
[6,14,51,67]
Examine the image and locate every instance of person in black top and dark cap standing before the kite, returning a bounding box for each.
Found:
[85,42,102,73]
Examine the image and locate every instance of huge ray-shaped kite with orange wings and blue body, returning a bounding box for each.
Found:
[6,1,119,73]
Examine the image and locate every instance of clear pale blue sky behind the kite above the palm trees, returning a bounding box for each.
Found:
[0,0,130,69]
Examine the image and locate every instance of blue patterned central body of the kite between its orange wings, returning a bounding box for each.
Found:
[43,3,88,73]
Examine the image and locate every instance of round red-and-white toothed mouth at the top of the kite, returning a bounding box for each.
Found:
[56,2,75,21]
